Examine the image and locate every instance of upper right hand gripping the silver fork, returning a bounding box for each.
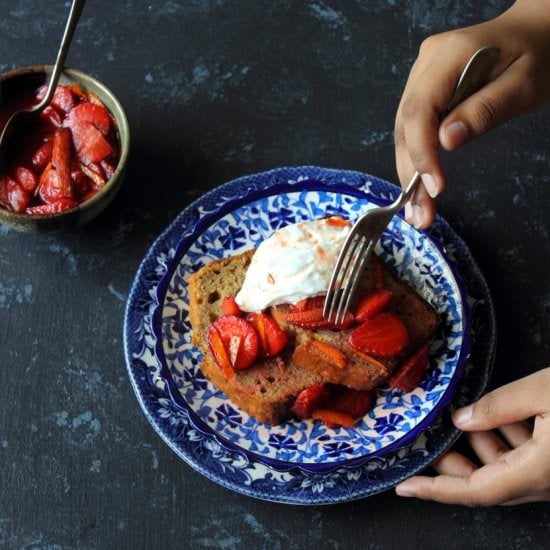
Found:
[395,0,550,227]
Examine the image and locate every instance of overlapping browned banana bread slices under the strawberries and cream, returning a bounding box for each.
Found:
[188,250,439,424]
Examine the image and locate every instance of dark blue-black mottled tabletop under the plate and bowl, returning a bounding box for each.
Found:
[0,0,550,550]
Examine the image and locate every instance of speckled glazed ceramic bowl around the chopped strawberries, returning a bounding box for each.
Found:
[0,65,130,232]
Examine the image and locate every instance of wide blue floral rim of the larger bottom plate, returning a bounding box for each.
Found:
[123,166,496,505]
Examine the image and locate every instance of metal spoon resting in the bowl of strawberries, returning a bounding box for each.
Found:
[0,0,86,152]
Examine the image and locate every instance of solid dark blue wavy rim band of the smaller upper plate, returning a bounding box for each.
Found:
[152,179,471,472]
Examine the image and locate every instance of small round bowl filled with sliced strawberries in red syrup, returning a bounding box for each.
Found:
[0,66,129,231]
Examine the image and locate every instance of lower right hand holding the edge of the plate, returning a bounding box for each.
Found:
[396,368,550,506]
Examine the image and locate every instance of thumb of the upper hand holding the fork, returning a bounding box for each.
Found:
[439,58,535,151]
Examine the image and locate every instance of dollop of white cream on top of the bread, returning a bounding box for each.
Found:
[235,217,351,311]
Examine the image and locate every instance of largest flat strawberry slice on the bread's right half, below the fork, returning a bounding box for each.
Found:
[348,313,409,358]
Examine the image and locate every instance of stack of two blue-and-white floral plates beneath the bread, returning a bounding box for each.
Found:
[125,167,500,503]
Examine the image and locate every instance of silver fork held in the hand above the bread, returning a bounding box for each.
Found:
[323,47,500,323]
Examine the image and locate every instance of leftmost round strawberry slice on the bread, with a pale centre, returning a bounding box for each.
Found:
[207,315,258,371]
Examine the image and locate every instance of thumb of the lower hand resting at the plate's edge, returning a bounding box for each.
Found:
[453,368,550,432]
